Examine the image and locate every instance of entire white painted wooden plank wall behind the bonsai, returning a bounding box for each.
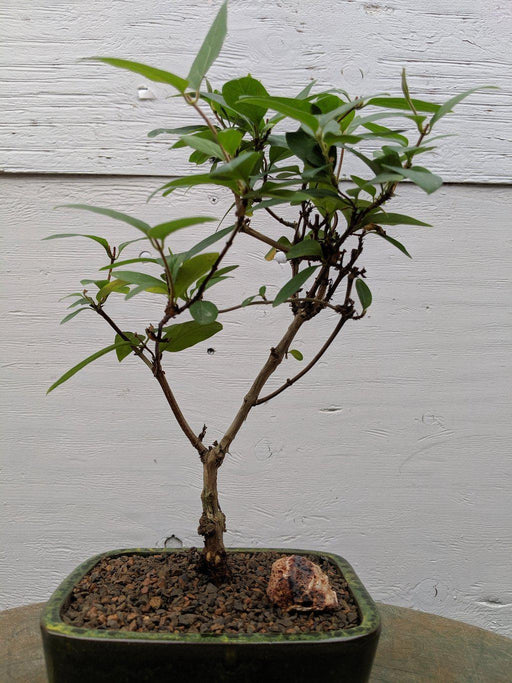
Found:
[0,0,512,633]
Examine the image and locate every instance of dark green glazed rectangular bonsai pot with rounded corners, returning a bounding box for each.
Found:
[41,548,380,683]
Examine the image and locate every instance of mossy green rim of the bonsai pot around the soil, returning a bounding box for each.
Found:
[41,548,381,645]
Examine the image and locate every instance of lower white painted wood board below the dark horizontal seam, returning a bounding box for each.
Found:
[0,177,512,633]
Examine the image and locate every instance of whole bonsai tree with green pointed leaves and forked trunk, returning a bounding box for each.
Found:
[46,3,488,576]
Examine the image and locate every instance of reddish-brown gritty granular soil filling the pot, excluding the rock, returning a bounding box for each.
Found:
[61,550,360,634]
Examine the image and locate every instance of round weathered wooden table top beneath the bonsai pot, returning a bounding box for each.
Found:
[0,603,512,683]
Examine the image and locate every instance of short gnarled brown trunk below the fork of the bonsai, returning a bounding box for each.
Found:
[197,447,228,579]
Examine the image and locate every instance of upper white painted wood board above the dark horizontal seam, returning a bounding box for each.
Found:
[0,0,512,183]
